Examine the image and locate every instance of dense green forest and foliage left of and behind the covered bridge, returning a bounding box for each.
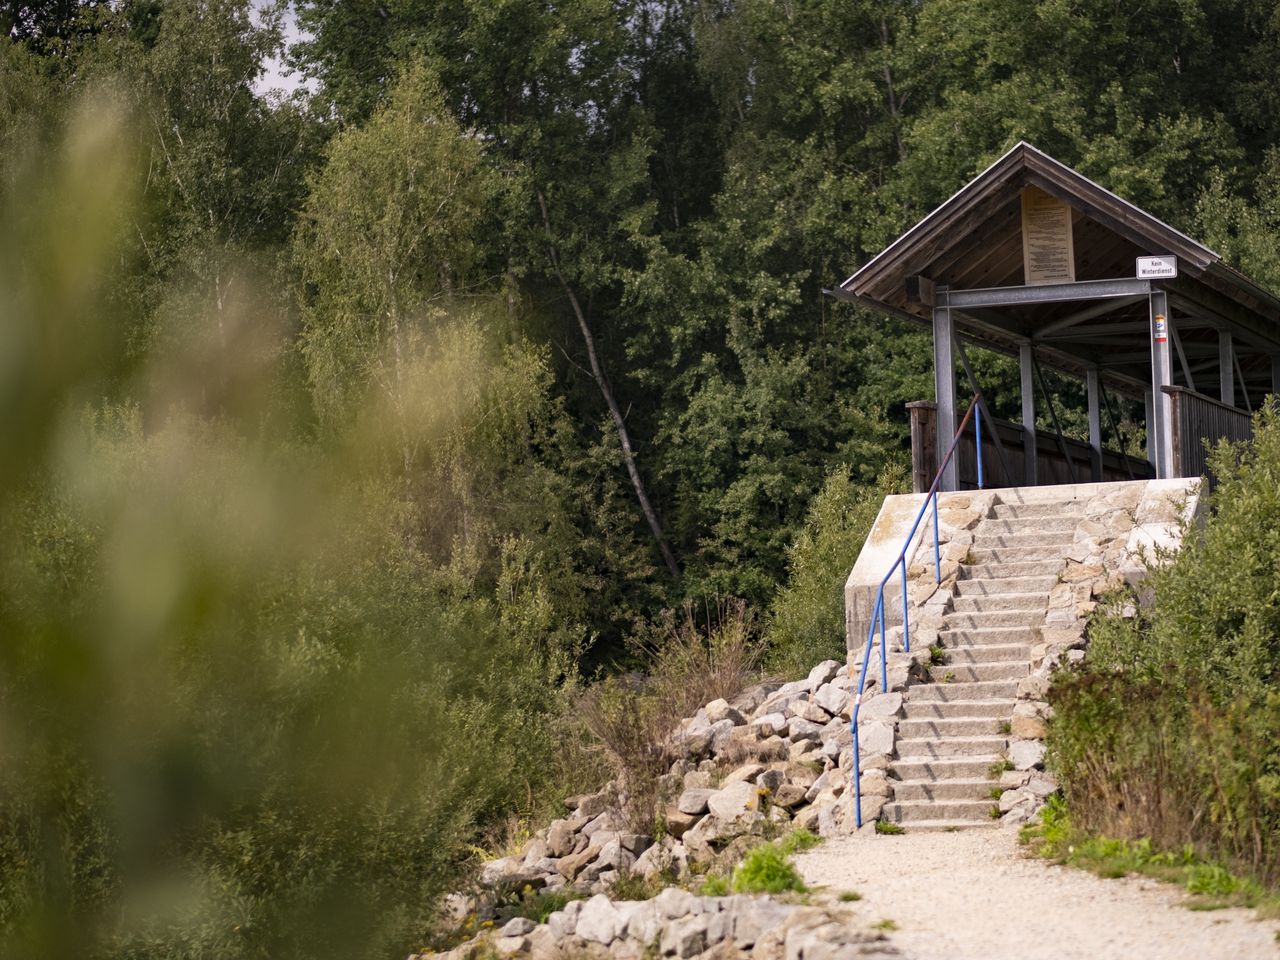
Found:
[0,0,1280,957]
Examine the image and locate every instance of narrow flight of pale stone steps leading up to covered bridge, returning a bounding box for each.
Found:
[882,499,1083,831]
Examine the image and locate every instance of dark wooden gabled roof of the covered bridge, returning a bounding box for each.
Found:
[832,141,1280,401]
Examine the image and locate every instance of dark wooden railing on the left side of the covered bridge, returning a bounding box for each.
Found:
[906,401,1155,493]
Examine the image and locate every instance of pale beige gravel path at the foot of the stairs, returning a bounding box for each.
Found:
[796,828,1280,960]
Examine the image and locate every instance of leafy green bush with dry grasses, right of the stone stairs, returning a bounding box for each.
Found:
[1050,404,1280,887]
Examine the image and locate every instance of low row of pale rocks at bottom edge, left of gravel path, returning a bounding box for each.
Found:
[410,887,899,960]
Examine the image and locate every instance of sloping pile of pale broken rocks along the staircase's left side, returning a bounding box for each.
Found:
[480,660,890,906]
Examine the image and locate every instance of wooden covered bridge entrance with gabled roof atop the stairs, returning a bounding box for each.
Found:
[831,142,1280,492]
